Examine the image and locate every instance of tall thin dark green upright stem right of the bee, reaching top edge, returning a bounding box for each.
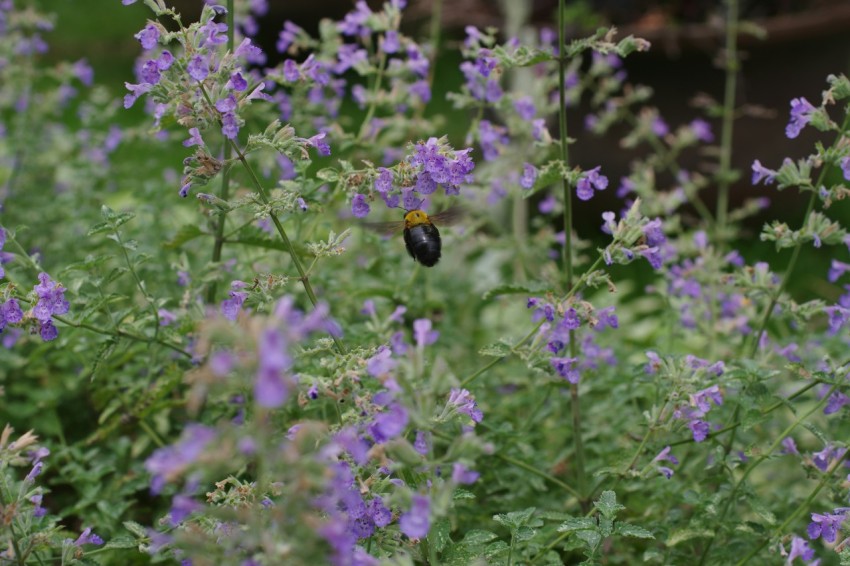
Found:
[558,0,585,502]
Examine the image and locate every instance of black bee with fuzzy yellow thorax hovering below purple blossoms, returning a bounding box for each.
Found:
[367,207,463,267]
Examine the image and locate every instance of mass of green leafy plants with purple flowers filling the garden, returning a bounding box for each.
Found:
[0,0,850,565]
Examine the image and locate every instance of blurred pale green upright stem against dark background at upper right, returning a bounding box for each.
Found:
[714,0,739,245]
